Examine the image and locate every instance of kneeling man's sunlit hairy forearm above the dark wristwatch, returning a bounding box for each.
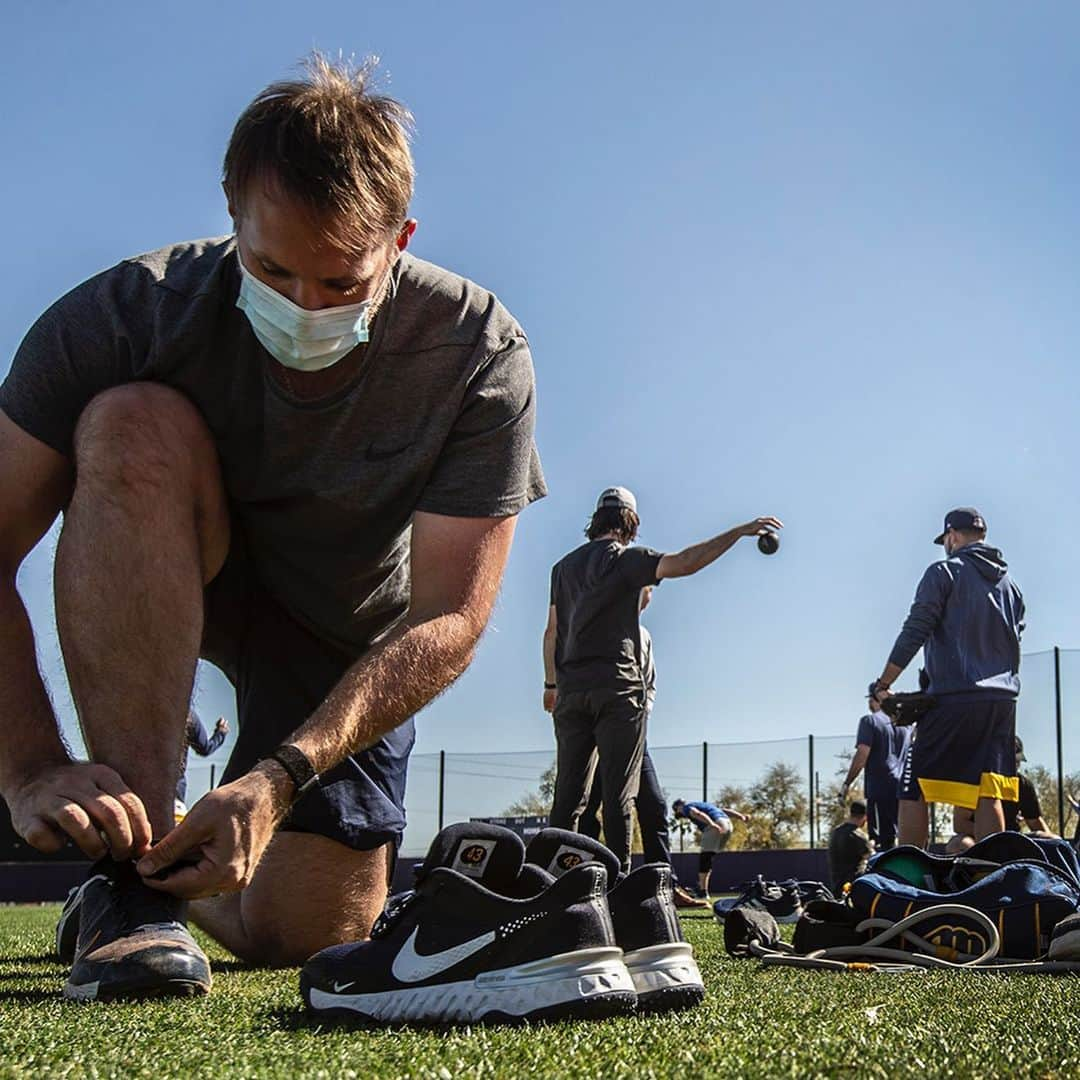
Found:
[280,612,483,772]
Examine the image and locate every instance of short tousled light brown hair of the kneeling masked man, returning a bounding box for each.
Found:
[221,53,416,255]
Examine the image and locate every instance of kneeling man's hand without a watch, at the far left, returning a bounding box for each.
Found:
[9,761,153,860]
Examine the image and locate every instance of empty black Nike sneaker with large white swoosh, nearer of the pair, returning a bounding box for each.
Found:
[300,822,636,1024]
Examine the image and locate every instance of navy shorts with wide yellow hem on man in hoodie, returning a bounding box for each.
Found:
[912,699,1020,810]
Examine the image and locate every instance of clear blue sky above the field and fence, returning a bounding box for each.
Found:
[0,0,1080,786]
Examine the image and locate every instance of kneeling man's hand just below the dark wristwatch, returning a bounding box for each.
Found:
[135,769,288,900]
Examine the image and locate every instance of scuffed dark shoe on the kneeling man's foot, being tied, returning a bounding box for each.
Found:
[63,856,211,1001]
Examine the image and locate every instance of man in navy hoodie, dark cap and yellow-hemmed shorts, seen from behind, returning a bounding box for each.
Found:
[869,507,1024,843]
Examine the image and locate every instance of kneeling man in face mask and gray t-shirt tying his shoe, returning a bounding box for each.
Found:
[0,56,544,999]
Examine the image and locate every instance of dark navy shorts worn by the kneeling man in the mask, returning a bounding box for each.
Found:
[200,526,415,851]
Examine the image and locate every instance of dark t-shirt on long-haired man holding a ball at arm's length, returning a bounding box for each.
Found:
[551,540,663,693]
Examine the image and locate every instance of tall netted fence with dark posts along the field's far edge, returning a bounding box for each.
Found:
[181,648,1080,858]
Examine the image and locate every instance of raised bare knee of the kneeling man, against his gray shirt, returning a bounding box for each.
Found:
[75,382,217,491]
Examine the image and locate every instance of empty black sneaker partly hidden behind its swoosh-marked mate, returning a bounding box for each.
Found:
[526,828,705,1012]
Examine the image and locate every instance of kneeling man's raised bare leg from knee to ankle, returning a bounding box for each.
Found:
[55,383,229,837]
